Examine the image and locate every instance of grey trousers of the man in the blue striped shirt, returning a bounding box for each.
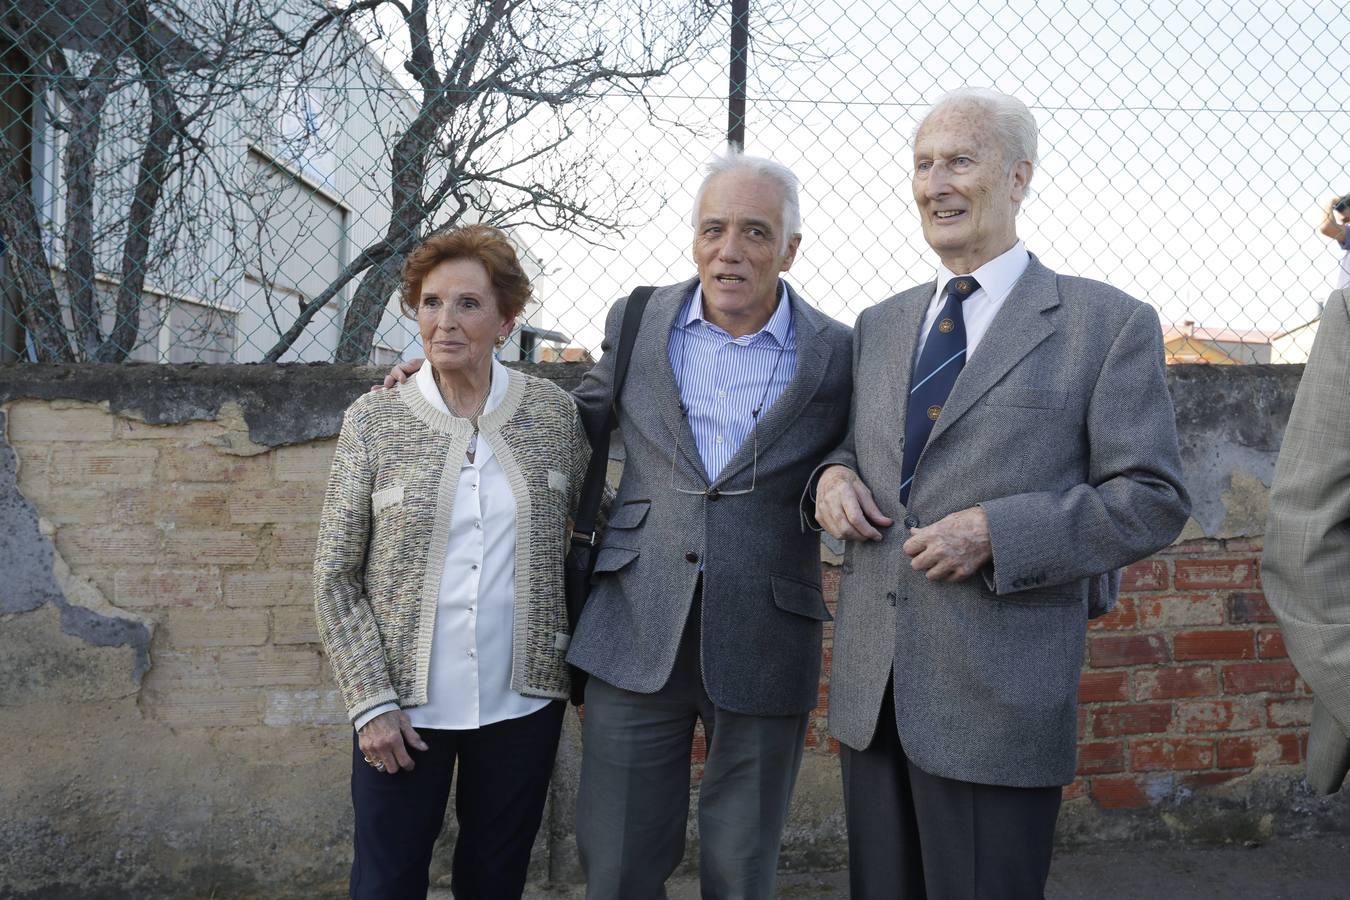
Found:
[576,593,807,900]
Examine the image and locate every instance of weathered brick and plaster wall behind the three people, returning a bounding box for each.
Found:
[0,367,1350,896]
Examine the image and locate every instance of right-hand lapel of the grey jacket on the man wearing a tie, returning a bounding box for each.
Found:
[926,255,1060,447]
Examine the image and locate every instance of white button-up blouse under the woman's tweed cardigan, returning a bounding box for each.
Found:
[355,359,549,730]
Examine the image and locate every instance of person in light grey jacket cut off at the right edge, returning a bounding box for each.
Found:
[1261,290,1350,793]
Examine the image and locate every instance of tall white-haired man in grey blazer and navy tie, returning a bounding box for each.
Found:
[806,89,1189,900]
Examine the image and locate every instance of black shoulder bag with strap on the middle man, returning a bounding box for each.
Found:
[563,287,656,706]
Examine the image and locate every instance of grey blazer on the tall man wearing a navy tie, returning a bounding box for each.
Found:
[803,256,1189,787]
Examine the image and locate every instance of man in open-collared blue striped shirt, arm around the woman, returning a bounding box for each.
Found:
[387,154,852,900]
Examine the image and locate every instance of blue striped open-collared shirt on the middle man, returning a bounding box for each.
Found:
[666,281,797,490]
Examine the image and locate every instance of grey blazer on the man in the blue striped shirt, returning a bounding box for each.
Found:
[567,281,852,715]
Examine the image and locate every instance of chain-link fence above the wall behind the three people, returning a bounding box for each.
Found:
[0,0,1350,363]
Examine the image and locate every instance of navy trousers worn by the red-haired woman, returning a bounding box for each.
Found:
[351,700,566,900]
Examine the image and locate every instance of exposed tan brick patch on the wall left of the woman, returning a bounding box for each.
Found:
[8,401,346,729]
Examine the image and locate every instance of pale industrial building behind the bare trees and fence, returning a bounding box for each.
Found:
[0,0,570,366]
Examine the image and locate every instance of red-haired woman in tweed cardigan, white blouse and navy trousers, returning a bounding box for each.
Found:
[315,225,590,900]
